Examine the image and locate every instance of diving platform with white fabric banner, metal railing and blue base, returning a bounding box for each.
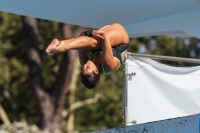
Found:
[92,52,200,133]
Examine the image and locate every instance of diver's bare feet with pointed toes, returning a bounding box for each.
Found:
[46,39,60,55]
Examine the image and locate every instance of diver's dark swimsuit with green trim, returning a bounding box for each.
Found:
[89,44,129,74]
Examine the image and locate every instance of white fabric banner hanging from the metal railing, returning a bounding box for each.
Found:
[123,57,200,125]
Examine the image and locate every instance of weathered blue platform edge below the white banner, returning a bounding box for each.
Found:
[92,114,200,133]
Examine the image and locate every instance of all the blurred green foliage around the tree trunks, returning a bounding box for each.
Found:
[0,12,200,132]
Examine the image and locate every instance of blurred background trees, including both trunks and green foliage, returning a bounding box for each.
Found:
[0,12,200,132]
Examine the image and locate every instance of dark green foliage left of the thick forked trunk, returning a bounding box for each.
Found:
[0,12,34,122]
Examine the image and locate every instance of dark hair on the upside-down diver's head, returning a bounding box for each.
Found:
[81,72,100,89]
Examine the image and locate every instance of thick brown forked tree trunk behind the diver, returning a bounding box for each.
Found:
[22,17,88,131]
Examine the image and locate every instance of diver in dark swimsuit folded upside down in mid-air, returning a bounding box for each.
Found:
[46,23,129,89]
